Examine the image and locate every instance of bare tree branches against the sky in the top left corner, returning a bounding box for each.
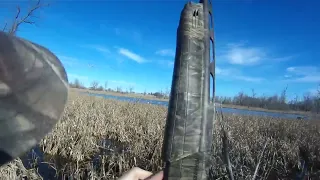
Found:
[3,0,49,36]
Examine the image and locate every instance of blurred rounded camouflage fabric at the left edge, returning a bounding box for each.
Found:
[0,32,68,165]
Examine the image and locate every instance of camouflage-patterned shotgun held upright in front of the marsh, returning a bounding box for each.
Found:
[162,0,215,180]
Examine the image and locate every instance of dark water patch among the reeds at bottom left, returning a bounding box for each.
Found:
[20,139,130,180]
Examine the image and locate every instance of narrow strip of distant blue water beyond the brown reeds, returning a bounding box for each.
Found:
[85,93,308,119]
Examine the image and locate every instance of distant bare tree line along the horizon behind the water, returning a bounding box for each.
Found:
[70,79,320,113]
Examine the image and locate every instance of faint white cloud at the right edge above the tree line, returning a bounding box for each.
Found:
[286,66,320,83]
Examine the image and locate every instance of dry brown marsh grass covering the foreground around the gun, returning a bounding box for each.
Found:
[0,93,320,179]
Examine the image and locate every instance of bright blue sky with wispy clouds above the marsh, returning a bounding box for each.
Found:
[0,0,320,98]
